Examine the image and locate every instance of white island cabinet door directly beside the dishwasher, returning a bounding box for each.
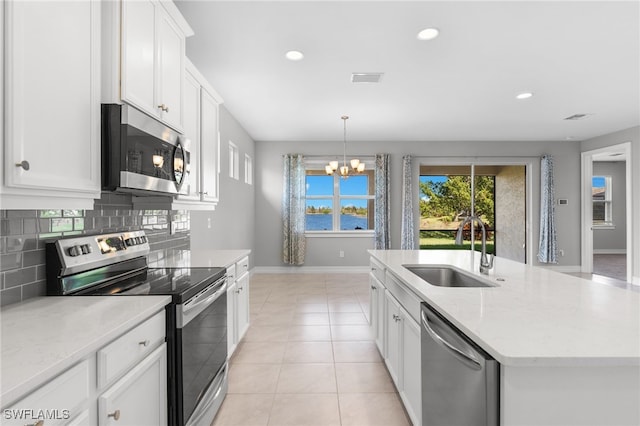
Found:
[400,309,422,424]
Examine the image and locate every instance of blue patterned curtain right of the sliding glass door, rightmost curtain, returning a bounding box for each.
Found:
[538,155,558,263]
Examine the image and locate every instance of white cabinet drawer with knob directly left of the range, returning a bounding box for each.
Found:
[98,311,166,389]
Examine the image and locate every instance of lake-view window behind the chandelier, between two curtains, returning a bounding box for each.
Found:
[306,169,374,232]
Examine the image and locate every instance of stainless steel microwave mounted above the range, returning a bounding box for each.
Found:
[102,104,191,196]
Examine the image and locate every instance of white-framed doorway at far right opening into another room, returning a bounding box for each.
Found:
[581,142,633,282]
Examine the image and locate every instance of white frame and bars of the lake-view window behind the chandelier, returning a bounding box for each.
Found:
[305,163,375,238]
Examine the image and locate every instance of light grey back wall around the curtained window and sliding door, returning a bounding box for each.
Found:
[255,141,580,270]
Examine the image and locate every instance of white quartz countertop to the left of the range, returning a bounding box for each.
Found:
[0,296,171,407]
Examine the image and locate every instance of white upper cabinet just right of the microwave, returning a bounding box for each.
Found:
[173,59,223,210]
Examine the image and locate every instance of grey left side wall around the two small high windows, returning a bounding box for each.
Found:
[191,104,255,262]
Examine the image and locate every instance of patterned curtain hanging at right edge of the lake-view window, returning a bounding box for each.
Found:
[373,154,391,250]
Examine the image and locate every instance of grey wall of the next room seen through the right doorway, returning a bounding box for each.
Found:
[593,161,627,253]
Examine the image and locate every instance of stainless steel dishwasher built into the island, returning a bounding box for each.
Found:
[421,303,500,426]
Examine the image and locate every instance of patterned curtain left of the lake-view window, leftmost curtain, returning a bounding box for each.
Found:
[282,154,306,265]
